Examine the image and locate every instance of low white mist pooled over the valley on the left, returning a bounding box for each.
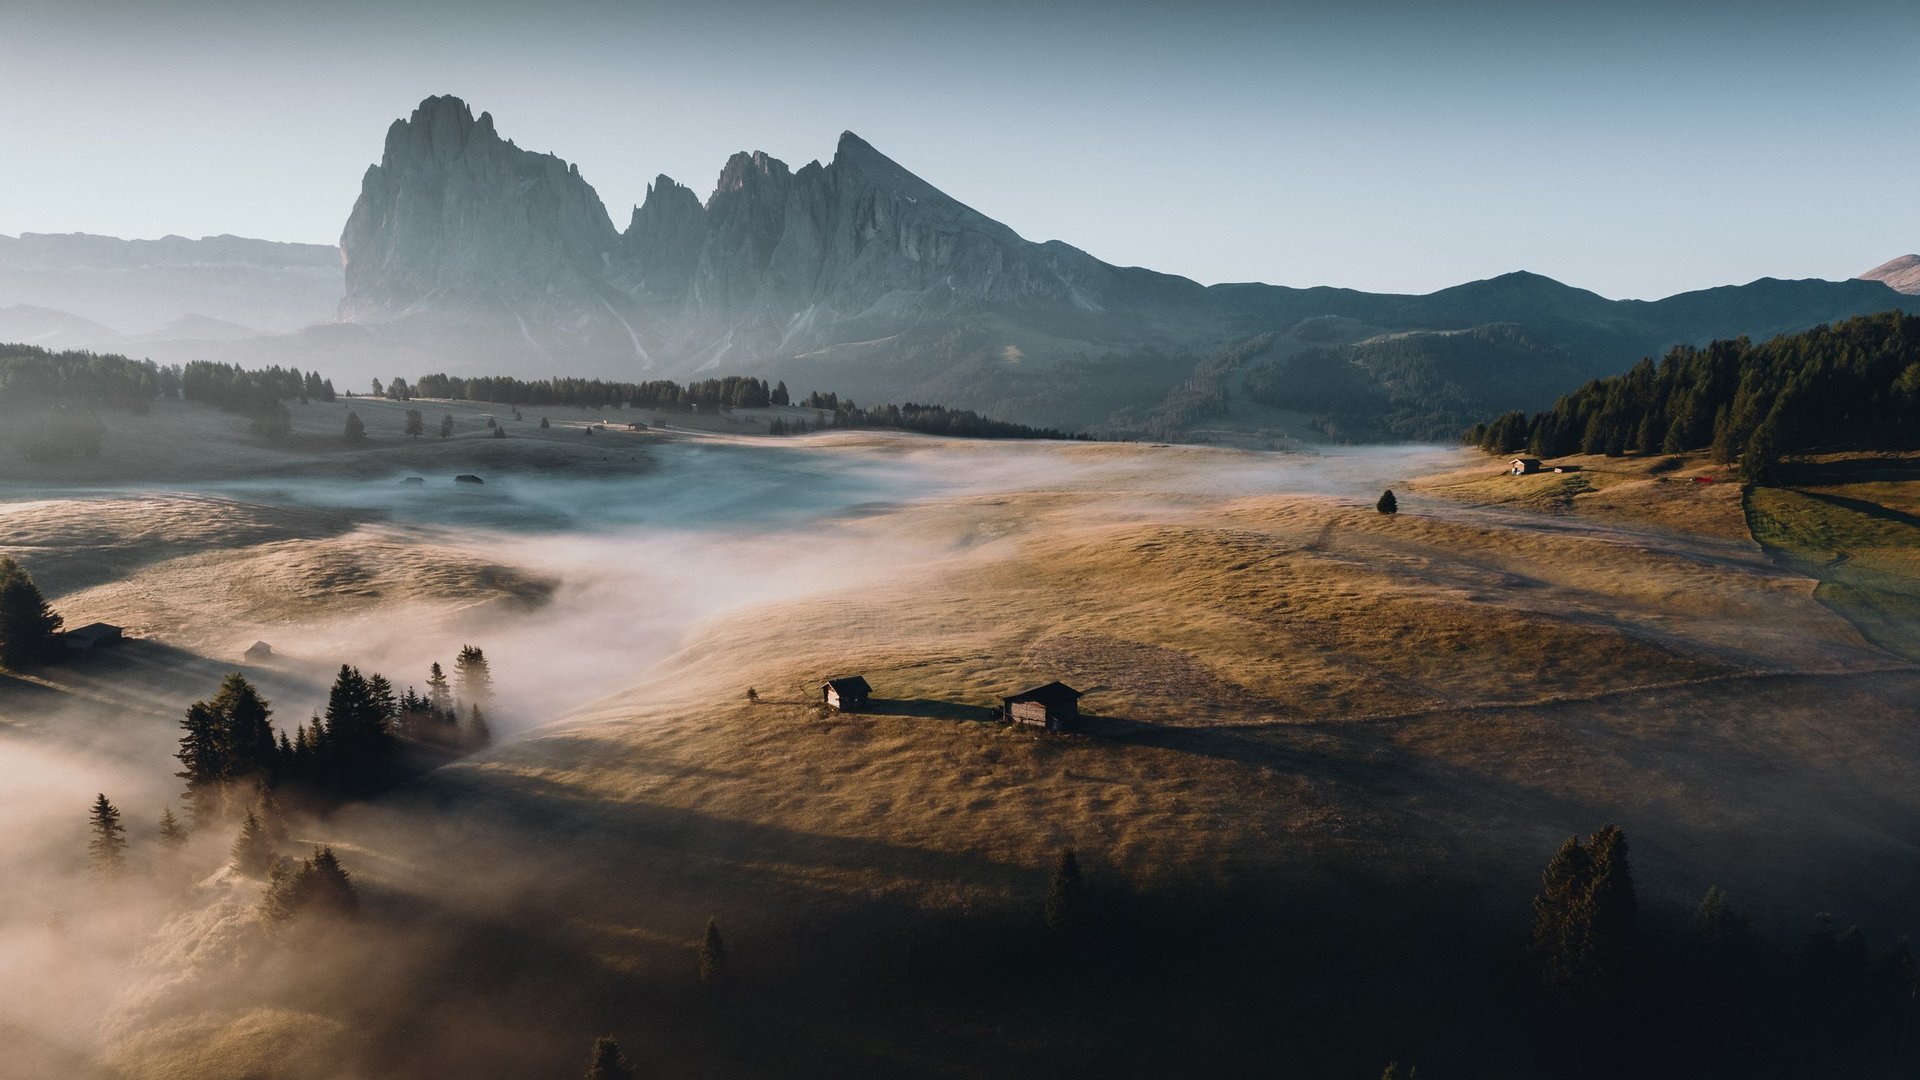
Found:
[0,436,1457,1076]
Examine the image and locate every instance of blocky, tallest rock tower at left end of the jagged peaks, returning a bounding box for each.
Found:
[340,98,618,338]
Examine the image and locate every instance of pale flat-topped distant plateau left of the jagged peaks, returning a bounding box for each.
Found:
[0,233,340,331]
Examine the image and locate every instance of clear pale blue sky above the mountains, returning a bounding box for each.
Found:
[0,0,1920,296]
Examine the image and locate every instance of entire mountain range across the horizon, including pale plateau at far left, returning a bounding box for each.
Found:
[0,96,1920,434]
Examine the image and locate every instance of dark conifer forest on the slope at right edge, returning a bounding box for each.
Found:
[1465,311,1920,480]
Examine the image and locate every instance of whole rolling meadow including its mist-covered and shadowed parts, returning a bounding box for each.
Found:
[0,417,1920,1080]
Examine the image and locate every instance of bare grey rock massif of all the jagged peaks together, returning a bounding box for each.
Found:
[340,98,1204,369]
